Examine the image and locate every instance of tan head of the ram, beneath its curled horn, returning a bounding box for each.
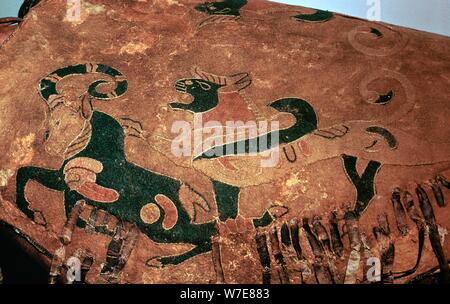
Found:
[44,97,92,158]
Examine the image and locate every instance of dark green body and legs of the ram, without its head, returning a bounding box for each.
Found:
[17,108,271,264]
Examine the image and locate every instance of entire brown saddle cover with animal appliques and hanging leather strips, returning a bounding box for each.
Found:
[0,0,450,284]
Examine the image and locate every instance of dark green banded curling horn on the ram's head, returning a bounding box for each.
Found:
[38,63,128,108]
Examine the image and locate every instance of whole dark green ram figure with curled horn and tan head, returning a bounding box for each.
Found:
[16,64,282,265]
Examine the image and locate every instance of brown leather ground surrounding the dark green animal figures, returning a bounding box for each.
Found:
[0,0,450,283]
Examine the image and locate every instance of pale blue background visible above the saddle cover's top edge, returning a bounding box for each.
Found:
[0,0,450,36]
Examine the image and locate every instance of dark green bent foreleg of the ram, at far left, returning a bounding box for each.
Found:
[16,167,65,220]
